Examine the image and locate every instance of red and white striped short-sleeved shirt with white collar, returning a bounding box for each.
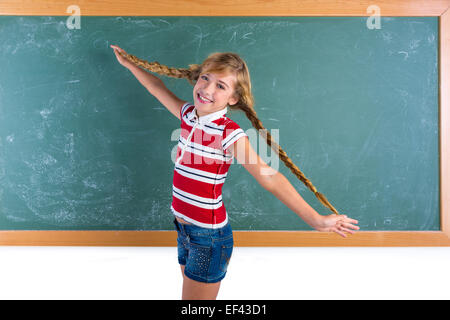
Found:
[171,103,247,229]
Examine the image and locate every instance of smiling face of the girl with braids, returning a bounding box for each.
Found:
[193,72,238,117]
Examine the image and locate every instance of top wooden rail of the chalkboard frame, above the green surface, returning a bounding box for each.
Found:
[0,0,450,17]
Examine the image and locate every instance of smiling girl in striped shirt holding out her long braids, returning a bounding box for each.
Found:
[111,45,359,299]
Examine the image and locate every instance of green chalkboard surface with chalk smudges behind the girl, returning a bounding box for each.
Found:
[0,16,440,230]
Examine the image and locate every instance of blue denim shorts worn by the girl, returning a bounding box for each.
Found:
[173,219,233,283]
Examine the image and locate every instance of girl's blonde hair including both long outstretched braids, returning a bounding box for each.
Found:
[119,51,339,214]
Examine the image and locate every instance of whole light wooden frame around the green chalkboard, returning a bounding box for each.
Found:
[0,0,450,247]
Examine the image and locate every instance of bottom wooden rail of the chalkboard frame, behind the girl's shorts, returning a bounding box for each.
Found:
[0,231,450,247]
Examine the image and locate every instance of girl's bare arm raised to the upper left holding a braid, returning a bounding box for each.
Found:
[111,45,186,119]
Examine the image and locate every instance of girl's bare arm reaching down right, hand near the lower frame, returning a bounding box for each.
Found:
[230,137,359,237]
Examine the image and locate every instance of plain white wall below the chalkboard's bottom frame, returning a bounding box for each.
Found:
[0,247,450,299]
